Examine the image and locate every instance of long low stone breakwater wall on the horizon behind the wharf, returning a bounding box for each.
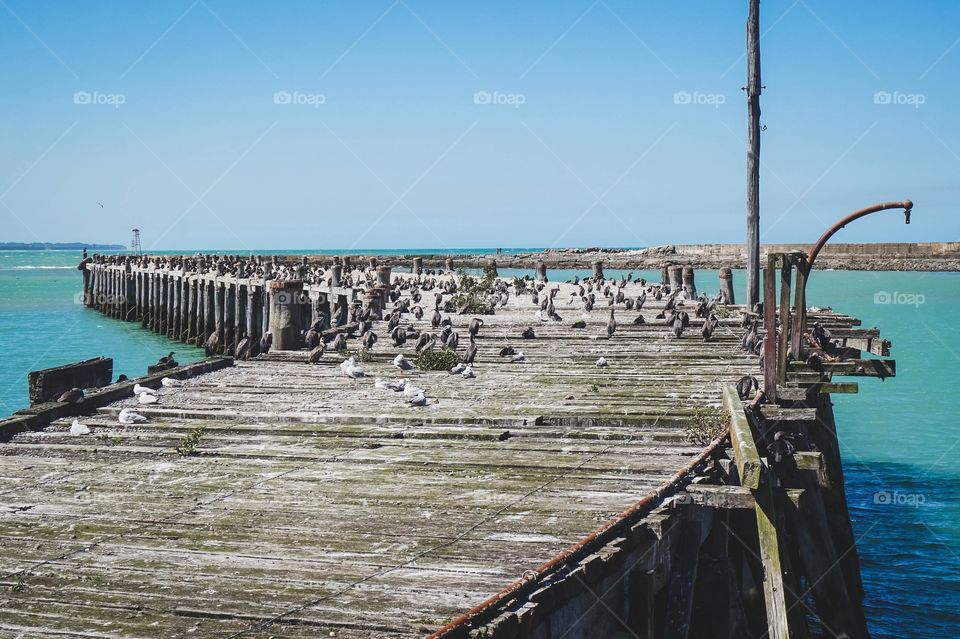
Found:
[304,242,960,271]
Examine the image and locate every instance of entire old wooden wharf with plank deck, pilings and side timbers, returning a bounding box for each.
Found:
[0,254,895,639]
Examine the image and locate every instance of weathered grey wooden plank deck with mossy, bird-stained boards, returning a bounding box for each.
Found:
[0,262,888,637]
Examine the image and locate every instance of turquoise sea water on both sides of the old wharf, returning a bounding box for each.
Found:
[0,249,960,639]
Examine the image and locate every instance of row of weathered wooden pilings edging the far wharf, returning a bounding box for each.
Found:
[80,256,734,354]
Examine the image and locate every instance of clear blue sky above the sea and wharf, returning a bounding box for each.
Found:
[0,0,960,249]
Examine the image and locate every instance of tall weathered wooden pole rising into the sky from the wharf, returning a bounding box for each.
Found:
[747,0,761,308]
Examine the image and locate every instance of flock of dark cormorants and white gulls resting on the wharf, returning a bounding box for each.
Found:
[69,254,831,448]
